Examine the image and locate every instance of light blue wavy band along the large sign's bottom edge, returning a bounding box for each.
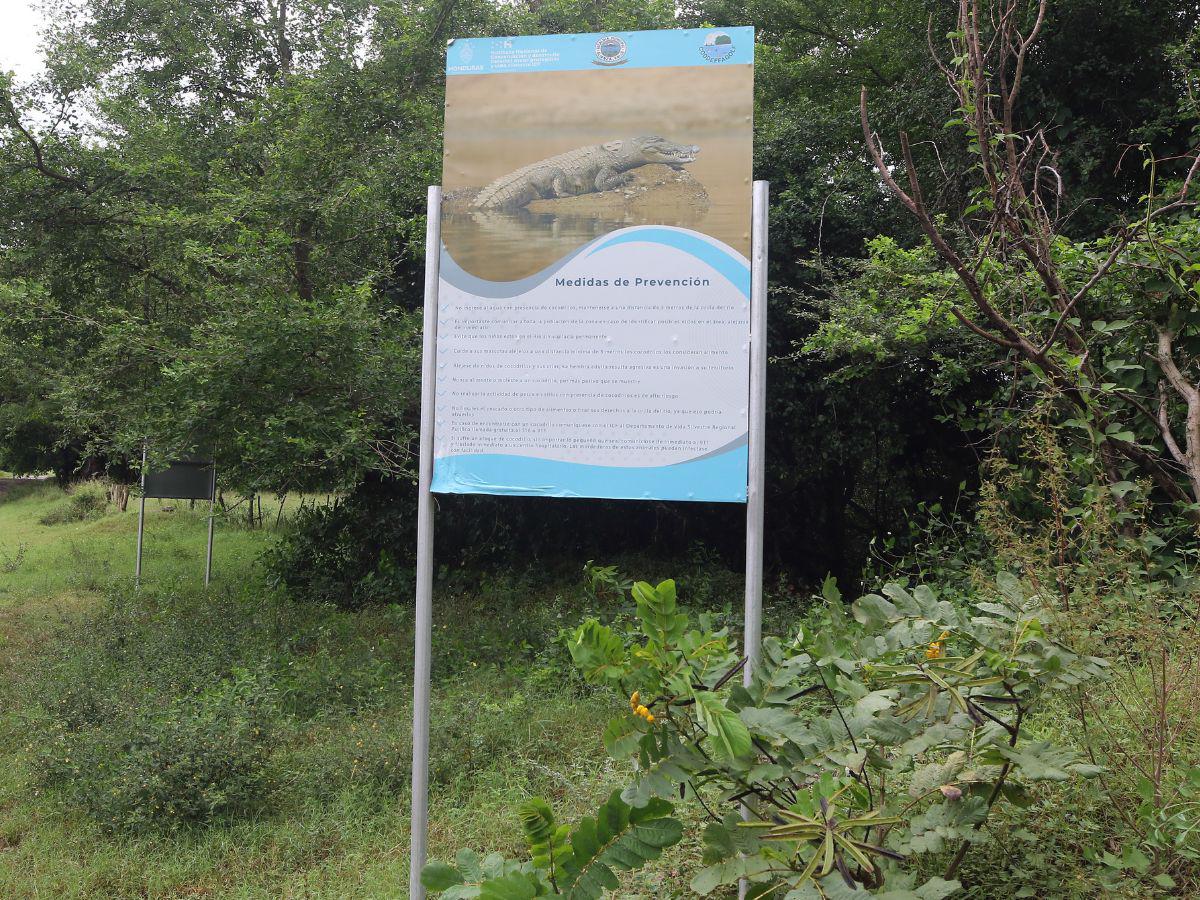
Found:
[431,444,749,503]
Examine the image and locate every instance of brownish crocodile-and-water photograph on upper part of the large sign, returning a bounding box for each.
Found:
[442,66,754,282]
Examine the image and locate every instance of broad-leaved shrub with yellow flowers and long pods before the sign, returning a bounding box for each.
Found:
[426,575,1105,900]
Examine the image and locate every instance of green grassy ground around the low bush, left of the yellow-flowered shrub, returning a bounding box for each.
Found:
[0,484,697,898]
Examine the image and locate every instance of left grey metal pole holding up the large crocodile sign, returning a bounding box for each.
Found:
[408,186,442,900]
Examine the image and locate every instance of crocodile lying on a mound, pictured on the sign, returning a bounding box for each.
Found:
[472,134,700,209]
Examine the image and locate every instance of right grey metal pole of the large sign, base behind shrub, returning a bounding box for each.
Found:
[738,181,770,900]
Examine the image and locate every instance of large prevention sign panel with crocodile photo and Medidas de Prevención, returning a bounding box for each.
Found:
[432,28,754,502]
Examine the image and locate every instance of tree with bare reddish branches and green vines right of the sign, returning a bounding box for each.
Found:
[860,0,1200,520]
